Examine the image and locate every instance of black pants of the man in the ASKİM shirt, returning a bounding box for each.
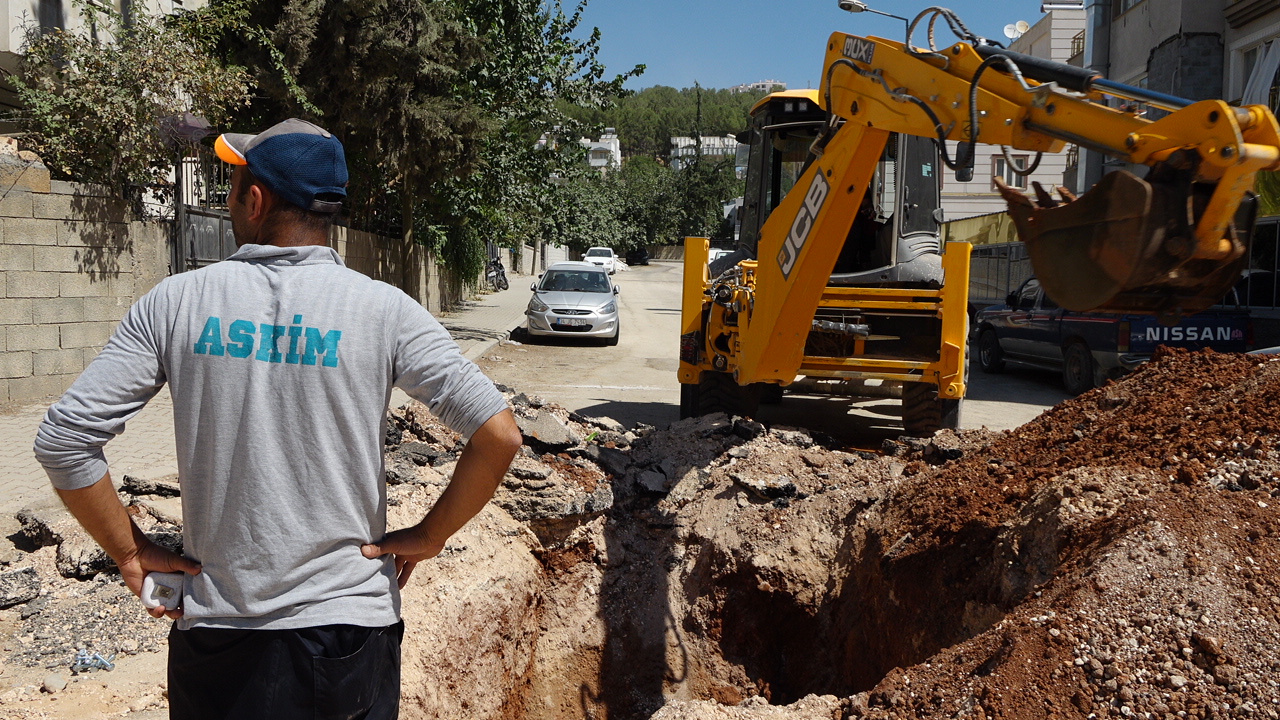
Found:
[169,621,404,720]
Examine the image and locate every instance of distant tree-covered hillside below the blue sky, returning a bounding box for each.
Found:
[564,85,764,158]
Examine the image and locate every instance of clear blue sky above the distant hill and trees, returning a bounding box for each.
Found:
[578,0,1042,90]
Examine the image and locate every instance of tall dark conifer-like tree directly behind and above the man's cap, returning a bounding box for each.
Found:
[229,0,493,240]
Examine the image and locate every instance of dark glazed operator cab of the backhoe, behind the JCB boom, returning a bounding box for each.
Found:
[727,90,942,288]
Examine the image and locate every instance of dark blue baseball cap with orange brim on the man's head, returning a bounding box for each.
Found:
[214,118,347,213]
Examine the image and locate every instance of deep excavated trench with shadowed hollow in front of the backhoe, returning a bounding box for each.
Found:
[517,425,1059,717]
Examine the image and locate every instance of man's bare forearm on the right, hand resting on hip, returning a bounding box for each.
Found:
[420,410,521,546]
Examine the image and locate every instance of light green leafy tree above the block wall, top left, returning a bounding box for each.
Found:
[10,0,248,201]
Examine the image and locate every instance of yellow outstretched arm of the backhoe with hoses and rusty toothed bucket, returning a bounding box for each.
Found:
[823,18,1280,315]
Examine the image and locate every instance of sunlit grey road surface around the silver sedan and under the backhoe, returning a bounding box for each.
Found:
[480,261,1068,438]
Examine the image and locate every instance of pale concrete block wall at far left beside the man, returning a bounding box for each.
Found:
[0,151,169,404]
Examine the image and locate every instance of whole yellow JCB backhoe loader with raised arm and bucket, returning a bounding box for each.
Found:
[678,8,1280,434]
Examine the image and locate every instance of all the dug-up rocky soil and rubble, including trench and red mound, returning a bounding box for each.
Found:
[0,351,1280,720]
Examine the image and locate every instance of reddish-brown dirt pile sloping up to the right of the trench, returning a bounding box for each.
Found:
[657,352,1280,719]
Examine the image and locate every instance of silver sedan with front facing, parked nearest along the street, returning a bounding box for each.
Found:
[525,263,620,345]
